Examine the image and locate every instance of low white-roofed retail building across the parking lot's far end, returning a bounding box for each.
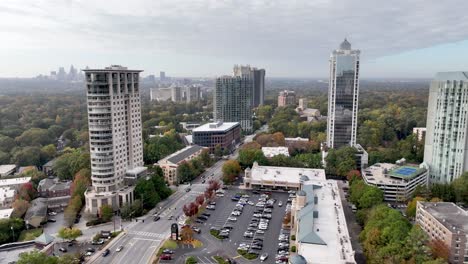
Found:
[242,162,325,190]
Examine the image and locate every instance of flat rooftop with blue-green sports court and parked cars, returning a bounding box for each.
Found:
[362,163,427,184]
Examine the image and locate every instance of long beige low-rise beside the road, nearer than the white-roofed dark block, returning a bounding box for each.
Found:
[155,145,208,184]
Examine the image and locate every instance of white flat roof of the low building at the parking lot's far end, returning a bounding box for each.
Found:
[250,162,326,183]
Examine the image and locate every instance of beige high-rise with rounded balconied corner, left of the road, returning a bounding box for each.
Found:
[84,65,146,213]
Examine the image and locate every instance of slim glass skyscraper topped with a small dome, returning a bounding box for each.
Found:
[327,39,361,148]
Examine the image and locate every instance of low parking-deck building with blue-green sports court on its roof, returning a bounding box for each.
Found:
[362,163,428,202]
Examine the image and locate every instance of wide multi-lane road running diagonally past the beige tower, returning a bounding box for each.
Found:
[89,160,224,264]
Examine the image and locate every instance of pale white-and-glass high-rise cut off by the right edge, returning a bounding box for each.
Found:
[424,72,468,183]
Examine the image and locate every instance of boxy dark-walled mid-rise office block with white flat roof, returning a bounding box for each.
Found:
[192,121,241,153]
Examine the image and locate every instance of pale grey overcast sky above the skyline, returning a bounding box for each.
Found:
[0,0,468,78]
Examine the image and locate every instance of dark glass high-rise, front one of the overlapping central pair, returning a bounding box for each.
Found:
[213,76,253,133]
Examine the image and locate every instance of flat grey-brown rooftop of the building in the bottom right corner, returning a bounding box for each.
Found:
[418,202,468,233]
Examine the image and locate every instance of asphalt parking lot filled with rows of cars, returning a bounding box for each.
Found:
[195,188,289,263]
